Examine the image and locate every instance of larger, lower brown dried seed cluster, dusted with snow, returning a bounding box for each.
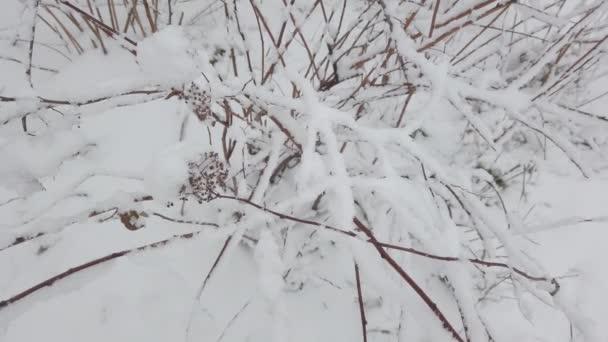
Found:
[181,152,228,203]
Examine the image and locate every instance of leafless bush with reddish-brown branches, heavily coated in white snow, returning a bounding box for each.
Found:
[0,0,608,341]
